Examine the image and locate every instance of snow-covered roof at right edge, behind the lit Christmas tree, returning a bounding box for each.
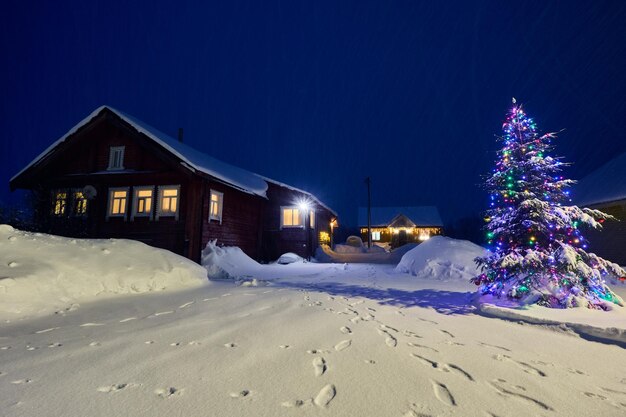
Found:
[572,153,626,206]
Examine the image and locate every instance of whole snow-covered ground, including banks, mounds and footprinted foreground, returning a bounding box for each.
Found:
[0,227,626,417]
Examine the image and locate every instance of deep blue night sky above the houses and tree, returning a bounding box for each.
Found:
[0,0,626,225]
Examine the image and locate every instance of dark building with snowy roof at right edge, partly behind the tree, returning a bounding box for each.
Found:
[573,153,626,265]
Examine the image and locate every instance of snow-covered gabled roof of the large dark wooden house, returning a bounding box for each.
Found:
[11,105,337,216]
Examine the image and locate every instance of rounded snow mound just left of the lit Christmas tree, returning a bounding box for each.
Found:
[395,236,486,281]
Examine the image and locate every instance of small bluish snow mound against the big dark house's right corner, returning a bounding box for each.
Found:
[202,240,261,281]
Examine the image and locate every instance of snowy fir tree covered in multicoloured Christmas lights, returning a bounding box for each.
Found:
[472,99,626,309]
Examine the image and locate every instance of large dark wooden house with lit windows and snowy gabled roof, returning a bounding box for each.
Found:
[10,106,337,261]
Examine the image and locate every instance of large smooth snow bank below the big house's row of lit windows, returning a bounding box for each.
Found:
[0,225,207,317]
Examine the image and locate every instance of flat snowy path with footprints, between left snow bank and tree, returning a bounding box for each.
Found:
[0,265,626,417]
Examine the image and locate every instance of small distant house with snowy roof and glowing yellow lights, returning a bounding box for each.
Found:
[359,206,443,247]
